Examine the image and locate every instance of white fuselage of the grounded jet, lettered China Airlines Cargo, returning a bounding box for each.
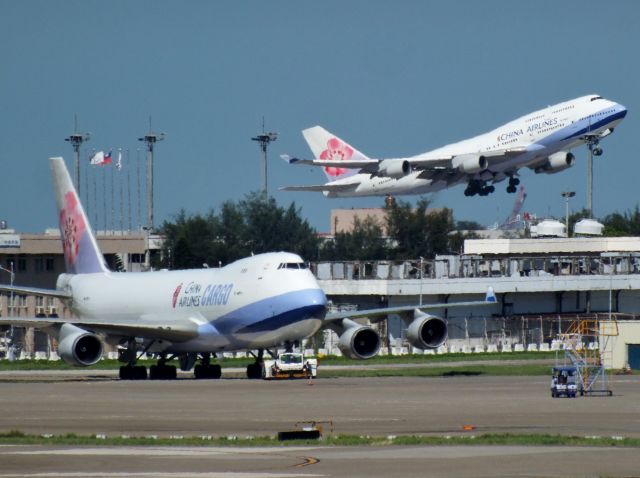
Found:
[58,252,326,352]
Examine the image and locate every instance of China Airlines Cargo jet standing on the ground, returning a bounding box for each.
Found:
[0,157,495,379]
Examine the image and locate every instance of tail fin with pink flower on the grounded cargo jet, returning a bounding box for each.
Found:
[49,157,109,274]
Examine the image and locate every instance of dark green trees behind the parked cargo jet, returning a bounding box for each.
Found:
[154,193,640,269]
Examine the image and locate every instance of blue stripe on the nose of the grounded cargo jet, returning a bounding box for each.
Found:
[211,289,327,335]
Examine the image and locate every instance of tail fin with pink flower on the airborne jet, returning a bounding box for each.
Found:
[302,126,369,181]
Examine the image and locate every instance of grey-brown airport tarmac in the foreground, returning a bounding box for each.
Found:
[0,372,640,478]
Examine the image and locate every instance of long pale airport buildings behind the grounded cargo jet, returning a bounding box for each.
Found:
[0,224,640,369]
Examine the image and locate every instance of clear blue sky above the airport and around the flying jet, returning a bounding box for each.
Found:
[0,0,640,232]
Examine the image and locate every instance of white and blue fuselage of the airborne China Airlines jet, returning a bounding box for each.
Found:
[324,95,627,197]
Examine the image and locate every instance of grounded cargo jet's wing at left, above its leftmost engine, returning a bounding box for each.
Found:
[0,317,198,342]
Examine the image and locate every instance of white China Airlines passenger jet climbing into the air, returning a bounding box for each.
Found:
[280,95,627,197]
